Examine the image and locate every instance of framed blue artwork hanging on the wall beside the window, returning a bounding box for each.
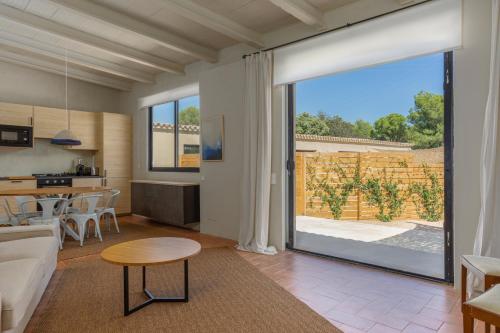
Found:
[201,115,224,162]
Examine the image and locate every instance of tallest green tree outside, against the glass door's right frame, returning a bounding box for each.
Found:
[407,91,444,149]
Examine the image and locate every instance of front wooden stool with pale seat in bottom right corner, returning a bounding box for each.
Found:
[462,285,500,333]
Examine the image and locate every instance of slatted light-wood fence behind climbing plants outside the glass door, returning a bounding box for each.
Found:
[296,151,444,220]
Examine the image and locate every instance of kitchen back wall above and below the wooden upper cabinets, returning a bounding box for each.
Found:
[0,62,120,177]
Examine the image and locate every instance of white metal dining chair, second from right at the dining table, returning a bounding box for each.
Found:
[62,194,102,246]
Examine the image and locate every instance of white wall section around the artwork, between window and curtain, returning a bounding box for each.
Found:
[200,61,244,239]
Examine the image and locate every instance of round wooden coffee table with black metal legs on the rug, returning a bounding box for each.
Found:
[101,237,201,316]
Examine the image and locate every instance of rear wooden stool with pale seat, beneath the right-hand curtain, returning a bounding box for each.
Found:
[461,255,500,333]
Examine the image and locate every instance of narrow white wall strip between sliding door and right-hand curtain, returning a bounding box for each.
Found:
[453,0,491,287]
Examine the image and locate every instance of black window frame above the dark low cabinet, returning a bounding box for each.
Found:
[148,95,201,173]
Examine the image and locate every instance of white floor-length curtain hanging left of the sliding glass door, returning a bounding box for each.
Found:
[238,52,276,254]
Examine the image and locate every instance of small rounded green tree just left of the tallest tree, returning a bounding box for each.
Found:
[372,113,408,142]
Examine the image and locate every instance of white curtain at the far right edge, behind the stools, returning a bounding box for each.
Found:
[474,0,500,258]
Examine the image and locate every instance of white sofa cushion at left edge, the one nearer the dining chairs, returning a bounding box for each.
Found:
[0,237,59,267]
